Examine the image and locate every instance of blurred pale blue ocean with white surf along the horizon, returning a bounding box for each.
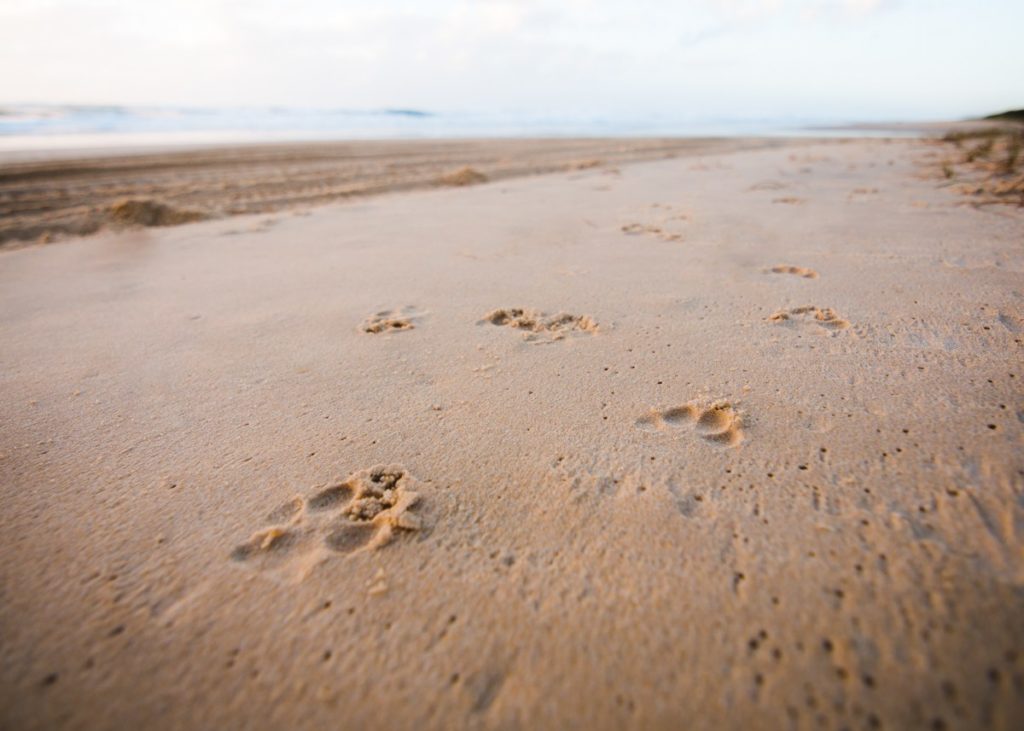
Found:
[0,104,913,151]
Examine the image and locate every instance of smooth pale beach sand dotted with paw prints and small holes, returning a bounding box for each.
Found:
[0,141,1024,729]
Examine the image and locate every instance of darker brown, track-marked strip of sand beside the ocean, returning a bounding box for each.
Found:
[0,138,783,248]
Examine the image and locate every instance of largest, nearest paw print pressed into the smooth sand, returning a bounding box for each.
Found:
[231,465,421,578]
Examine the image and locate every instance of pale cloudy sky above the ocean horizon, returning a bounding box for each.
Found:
[0,0,1024,121]
